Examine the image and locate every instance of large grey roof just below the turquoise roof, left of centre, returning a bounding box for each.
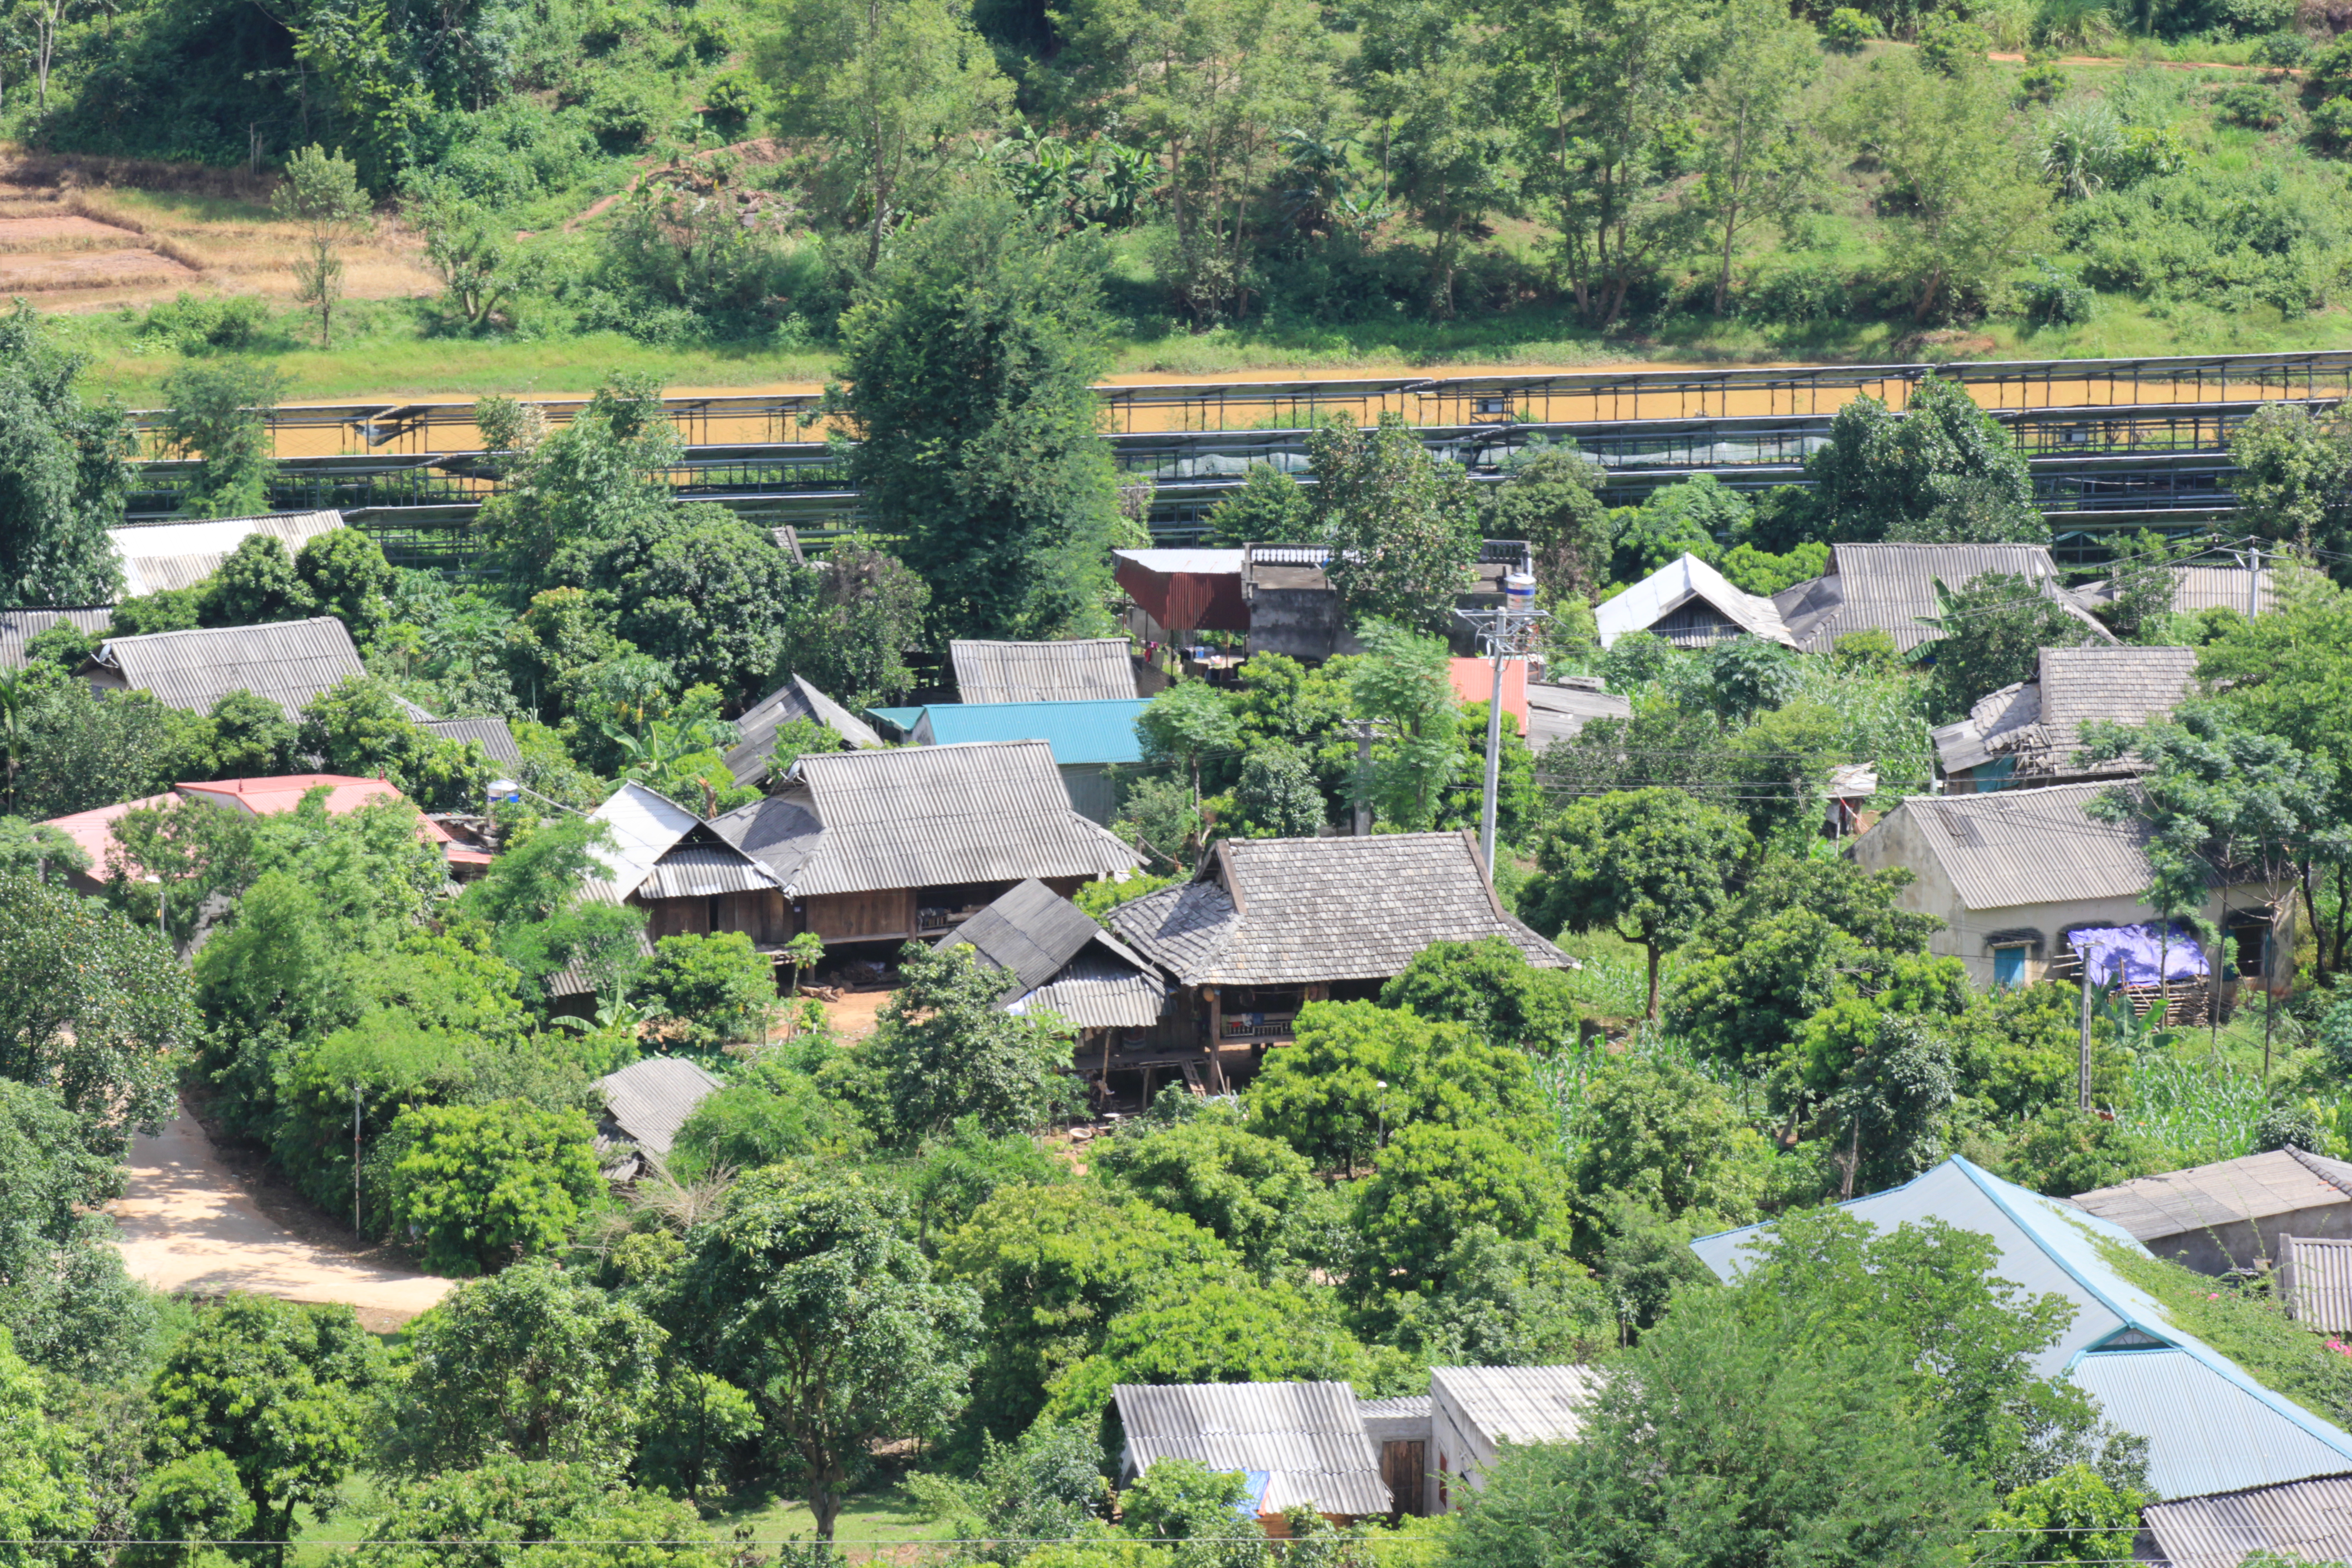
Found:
[713,740,1138,898]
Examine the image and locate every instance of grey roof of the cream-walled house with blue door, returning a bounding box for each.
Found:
[1870,783,2152,910]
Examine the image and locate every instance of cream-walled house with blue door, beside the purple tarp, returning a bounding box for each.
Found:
[1851,783,2272,990]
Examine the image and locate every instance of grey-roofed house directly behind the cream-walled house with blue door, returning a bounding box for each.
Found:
[1929,647,2197,794]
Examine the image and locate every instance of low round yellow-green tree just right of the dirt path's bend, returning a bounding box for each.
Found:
[391,1100,604,1274]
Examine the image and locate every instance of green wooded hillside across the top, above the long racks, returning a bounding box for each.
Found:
[14,0,2352,369]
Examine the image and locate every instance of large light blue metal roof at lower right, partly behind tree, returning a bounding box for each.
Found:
[1691,1159,2352,1498]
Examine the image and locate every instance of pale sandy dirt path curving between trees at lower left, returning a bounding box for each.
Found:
[113,1107,449,1333]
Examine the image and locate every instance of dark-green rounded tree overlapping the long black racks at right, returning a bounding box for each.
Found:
[1804,376,2048,543]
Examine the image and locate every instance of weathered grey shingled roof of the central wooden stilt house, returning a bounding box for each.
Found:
[1110,832,1569,985]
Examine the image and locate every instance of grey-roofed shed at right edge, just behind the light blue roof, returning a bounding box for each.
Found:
[2074,1150,2352,1274]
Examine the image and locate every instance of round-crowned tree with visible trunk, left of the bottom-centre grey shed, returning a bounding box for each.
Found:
[670,1166,981,1540]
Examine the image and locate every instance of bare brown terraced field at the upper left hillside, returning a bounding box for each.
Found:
[0,153,437,310]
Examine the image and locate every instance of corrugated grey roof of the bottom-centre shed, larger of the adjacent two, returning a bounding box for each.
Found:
[1110,1382,1395,1519]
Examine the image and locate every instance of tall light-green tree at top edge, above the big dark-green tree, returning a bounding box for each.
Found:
[755,0,1011,275]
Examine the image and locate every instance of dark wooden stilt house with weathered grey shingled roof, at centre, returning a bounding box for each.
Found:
[1103,832,1571,1102]
